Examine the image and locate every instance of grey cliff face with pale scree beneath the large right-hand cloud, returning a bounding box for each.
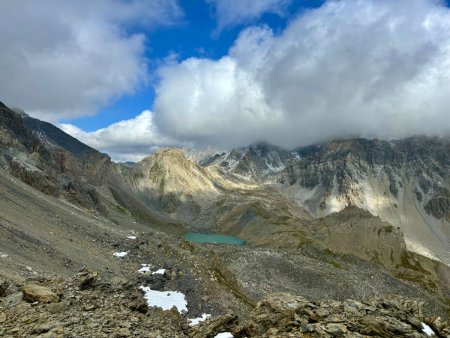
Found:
[278,137,450,263]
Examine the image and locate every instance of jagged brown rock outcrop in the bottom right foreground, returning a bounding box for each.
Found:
[200,294,450,338]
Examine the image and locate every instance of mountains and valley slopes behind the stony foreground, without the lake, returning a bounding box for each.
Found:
[0,103,450,336]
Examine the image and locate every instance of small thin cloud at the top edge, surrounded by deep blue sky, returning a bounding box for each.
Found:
[206,0,292,31]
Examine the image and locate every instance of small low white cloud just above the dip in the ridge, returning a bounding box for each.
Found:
[59,110,187,161]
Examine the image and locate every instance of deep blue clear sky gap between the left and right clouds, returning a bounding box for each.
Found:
[60,0,324,131]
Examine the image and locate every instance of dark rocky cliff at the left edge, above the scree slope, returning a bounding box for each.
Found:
[0,104,111,212]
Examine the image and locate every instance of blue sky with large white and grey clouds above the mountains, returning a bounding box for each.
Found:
[0,0,450,161]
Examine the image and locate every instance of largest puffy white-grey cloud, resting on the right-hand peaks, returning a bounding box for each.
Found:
[155,0,450,147]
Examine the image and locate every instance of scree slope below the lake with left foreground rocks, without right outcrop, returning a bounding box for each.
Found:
[0,161,446,337]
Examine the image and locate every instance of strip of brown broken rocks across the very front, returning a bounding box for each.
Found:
[0,269,450,338]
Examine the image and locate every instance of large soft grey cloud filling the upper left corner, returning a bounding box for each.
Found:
[0,0,182,122]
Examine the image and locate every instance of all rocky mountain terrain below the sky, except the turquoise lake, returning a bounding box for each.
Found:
[0,100,450,337]
